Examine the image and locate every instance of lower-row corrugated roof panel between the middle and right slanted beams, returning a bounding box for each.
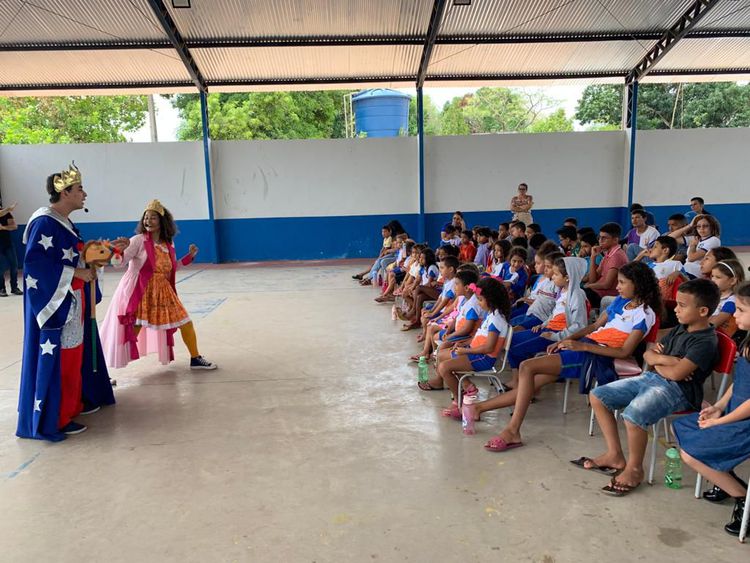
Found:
[427,41,645,77]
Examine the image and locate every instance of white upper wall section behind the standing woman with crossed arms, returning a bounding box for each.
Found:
[425,131,625,213]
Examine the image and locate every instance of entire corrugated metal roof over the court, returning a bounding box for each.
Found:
[0,0,750,95]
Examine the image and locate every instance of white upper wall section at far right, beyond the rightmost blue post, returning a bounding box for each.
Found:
[633,129,750,209]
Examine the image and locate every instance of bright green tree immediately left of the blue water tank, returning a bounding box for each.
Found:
[170,90,354,141]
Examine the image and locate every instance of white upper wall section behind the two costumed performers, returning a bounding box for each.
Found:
[0,142,208,223]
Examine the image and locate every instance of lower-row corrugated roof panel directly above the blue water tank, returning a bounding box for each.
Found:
[191,45,422,81]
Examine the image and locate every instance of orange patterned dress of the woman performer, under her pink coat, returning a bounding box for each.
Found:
[135,246,190,330]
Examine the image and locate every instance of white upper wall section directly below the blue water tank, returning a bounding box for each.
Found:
[212,137,419,218]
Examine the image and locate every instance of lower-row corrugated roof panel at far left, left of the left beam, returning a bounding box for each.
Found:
[0,49,190,85]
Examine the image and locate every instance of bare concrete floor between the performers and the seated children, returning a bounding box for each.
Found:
[0,263,750,563]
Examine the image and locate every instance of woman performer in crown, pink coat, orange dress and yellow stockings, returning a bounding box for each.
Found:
[100,200,217,370]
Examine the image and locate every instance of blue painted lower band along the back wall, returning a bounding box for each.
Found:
[13,203,750,262]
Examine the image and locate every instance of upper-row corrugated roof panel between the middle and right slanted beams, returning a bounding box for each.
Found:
[440,0,691,36]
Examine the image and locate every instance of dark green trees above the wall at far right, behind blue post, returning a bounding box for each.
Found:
[575,82,750,130]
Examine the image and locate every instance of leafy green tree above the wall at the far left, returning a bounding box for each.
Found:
[0,96,148,145]
